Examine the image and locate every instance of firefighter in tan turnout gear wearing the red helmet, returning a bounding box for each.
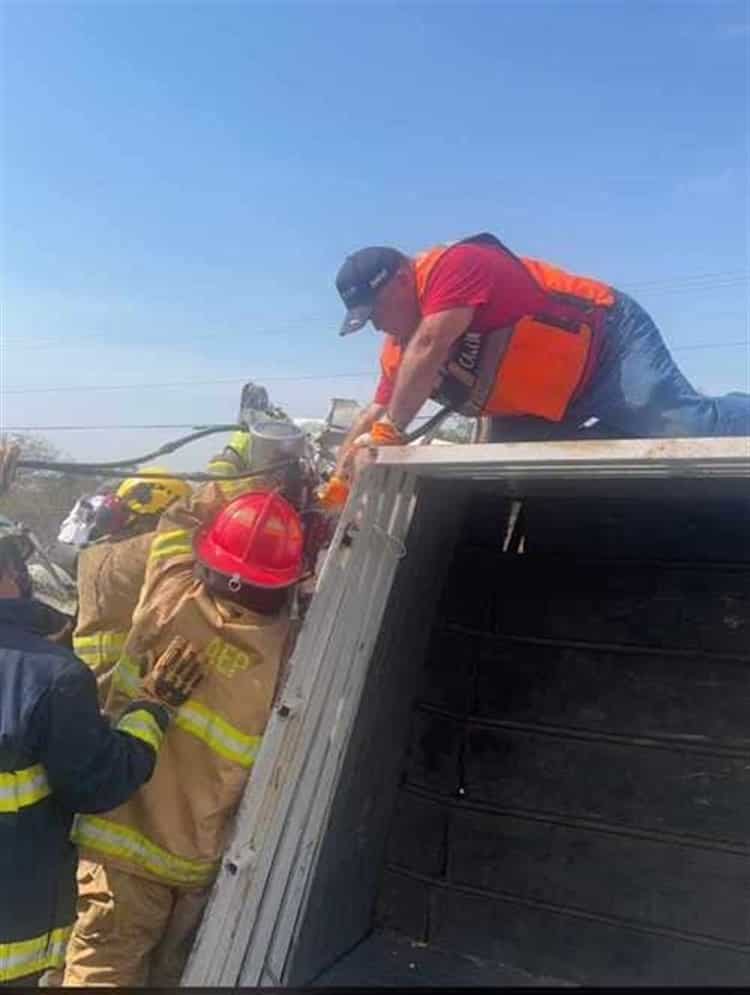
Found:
[65,484,303,987]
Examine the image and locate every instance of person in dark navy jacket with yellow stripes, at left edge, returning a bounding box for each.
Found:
[0,519,202,986]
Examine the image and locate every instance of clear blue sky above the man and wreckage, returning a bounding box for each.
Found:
[0,0,750,465]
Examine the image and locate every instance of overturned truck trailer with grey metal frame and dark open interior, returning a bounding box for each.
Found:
[183,439,750,988]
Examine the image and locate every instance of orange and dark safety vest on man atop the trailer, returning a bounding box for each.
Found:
[380,234,615,422]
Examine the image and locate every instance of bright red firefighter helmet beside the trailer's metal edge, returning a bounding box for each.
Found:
[195,491,304,589]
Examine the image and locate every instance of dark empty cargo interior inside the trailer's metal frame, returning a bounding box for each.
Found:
[286,485,750,987]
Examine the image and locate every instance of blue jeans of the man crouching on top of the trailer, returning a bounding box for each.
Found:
[491,292,750,442]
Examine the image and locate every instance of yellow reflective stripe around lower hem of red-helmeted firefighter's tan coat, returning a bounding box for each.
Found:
[72,816,219,886]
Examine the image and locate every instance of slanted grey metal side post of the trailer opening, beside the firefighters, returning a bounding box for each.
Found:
[182,469,415,986]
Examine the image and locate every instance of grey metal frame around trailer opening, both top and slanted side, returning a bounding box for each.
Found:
[182,437,750,986]
